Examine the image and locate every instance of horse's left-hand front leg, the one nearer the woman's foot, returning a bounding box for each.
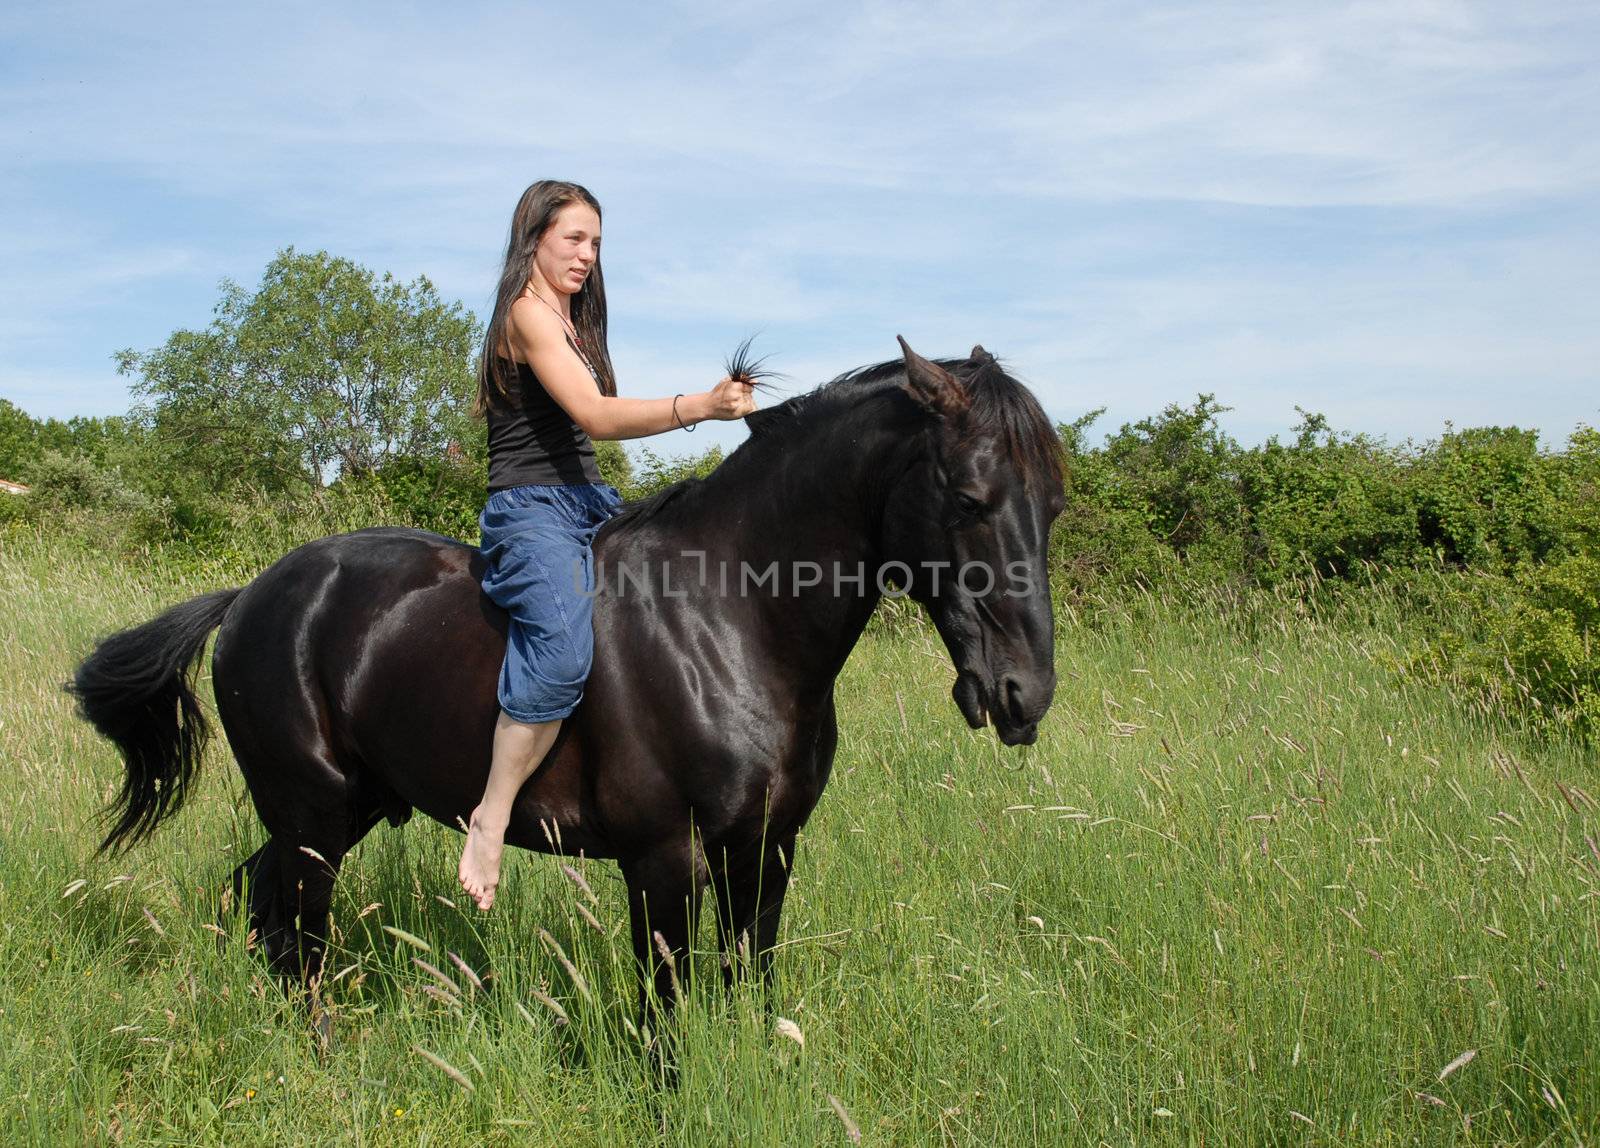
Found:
[622,843,706,1036]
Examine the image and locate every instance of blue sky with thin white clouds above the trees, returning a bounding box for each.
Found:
[0,0,1600,452]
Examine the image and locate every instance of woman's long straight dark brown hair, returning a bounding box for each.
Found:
[472,179,616,416]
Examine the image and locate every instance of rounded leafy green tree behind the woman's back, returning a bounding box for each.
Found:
[117,248,482,491]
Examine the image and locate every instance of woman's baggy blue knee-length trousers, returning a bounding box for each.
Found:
[478,483,622,723]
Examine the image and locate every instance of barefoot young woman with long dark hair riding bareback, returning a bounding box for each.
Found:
[459,179,755,910]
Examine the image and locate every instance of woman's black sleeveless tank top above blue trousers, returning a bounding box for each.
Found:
[488,360,605,494]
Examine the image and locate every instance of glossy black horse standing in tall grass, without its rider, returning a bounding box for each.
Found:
[70,341,1062,1023]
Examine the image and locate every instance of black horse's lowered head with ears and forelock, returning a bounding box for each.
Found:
[883,339,1064,745]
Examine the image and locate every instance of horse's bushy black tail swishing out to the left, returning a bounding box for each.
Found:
[67,590,238,852]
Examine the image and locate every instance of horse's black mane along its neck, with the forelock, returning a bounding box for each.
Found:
[611,352,1062,526]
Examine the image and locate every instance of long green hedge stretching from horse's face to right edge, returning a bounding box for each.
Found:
[1054,409,1600,587]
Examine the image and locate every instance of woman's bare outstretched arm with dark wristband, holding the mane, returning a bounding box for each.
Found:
[506,296,755,438]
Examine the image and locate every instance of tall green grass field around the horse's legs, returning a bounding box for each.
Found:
[0,539,1600,1145]
